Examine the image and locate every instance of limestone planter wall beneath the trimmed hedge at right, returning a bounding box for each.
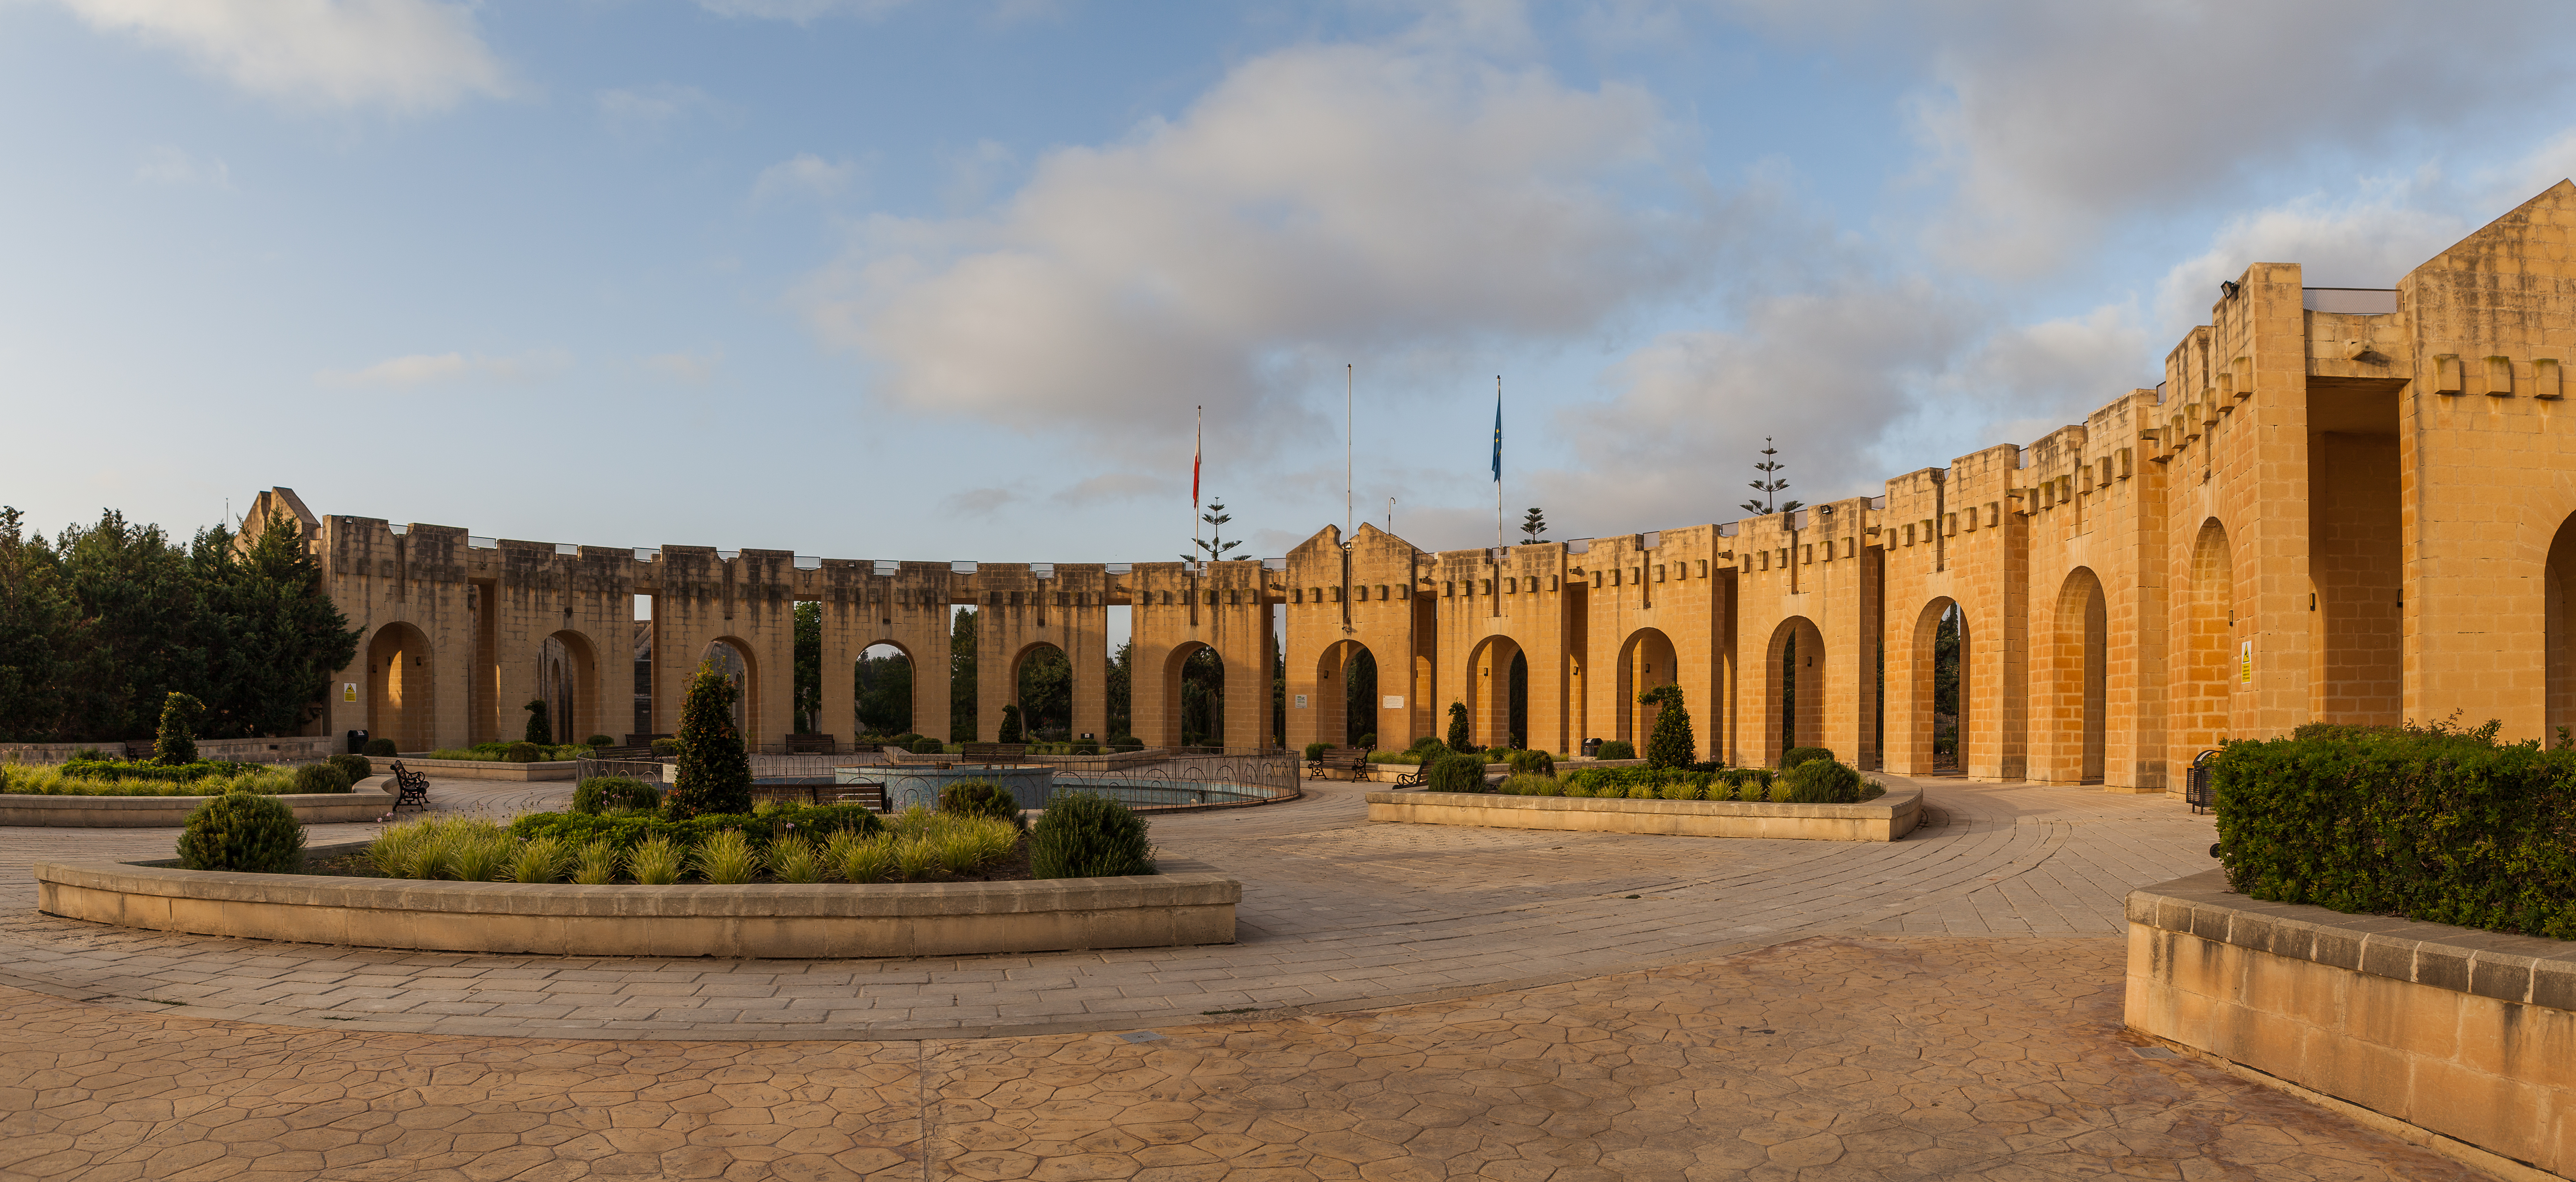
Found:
[2128,871,2576,1177]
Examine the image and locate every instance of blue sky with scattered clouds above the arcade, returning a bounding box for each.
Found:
[0,0,2576,561]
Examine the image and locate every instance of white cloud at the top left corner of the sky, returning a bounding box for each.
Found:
[59,0,505,111]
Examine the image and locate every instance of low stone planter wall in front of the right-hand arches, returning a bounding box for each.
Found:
[1368,788,1922,842]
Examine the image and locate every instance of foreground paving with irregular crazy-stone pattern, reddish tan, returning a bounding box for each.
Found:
[0,935,2481,1182]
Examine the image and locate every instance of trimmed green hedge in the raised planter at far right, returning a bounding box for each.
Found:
[2210,724,2576,940]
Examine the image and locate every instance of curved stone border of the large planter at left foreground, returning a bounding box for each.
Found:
[34,842,1244,958]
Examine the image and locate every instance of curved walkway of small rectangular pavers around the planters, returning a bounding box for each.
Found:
[0,780,2213,1041]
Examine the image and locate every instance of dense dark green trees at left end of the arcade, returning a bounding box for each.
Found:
[0,507,358,742]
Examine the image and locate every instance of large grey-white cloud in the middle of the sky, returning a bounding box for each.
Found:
[804,46,1718,443]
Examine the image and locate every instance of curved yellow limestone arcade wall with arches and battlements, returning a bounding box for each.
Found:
[252,183,2576,791]
